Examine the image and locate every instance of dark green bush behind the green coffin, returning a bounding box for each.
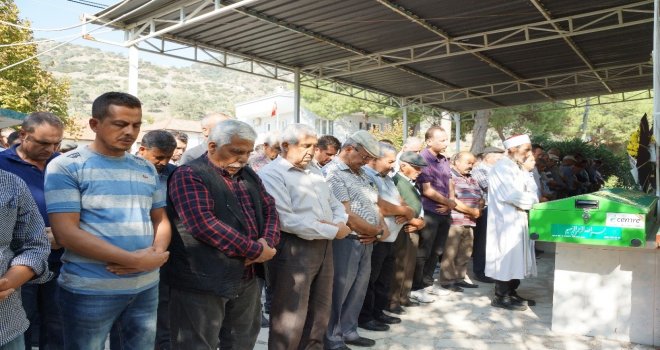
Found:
[532,137,636,188]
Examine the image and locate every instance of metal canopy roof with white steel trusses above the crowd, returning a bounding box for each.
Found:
[95,0,653,112]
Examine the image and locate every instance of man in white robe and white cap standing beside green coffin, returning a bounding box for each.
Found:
[486,135,539,311]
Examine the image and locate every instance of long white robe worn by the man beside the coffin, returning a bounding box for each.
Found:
[485,157,539,281]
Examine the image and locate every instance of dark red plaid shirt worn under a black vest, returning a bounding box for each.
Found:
[168,156,280,278]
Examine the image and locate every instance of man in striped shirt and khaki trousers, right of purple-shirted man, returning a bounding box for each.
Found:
[440,152,483,292]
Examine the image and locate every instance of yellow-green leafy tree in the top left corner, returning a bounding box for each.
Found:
[0,0,69,123]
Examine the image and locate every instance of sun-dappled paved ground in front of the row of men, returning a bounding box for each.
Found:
[255,253,654,350]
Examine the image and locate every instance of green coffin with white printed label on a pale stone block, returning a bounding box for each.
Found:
[529,188,657,247]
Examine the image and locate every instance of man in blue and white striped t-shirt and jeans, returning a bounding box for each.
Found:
[45,92,170,350]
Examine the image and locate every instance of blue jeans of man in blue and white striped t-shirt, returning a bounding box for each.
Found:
[59,286,158,350]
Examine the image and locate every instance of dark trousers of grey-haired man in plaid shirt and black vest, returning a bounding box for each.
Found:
[169,278,261,350]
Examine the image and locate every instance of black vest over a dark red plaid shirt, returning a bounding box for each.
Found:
[161,157,264,298]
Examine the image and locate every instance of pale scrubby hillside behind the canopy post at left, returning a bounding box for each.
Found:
[39,40,282,120]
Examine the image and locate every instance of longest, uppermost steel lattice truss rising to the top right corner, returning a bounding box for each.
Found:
[303,0,653,78]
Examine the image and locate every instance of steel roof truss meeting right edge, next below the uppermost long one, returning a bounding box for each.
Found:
[408,62,653,105]
